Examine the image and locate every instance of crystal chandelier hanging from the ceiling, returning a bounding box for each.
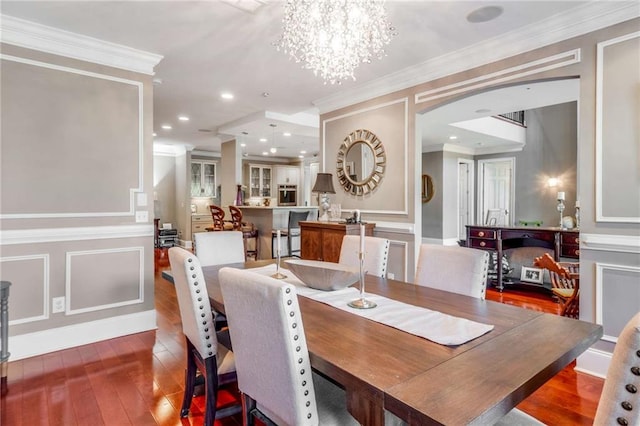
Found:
[275,0,396,84]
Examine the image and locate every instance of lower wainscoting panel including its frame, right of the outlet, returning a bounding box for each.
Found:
[65,247,144,315]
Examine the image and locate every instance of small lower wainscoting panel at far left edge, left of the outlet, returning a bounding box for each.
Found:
[0,254,49,325]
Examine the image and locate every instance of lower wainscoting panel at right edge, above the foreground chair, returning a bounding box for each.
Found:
[596,262,640,343]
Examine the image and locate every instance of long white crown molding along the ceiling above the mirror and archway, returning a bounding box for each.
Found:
[313,1,640,114]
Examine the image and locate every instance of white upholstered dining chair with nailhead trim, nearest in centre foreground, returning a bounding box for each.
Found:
[219,268,358,426]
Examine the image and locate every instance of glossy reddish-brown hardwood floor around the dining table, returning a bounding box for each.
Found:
[0,253,603,426]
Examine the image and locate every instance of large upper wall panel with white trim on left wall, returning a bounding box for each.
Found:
[0,55,144,219]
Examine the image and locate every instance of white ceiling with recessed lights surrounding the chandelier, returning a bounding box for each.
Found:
[2,0,640,157]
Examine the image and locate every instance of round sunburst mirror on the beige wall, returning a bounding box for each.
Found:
[336,129,387,195]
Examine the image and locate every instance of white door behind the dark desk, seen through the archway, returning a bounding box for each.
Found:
[477,157,515,226]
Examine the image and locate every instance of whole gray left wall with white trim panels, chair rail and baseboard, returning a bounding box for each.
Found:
[0,45,155,359]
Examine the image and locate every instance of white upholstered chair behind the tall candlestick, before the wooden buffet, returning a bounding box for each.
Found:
[338,235,389,278]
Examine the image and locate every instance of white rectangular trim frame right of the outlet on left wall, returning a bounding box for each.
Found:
[64,247,144,315]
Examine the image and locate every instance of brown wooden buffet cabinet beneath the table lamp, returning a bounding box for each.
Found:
[300,221,376,263]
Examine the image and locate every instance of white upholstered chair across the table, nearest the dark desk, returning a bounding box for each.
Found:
[415,244,489,299]
